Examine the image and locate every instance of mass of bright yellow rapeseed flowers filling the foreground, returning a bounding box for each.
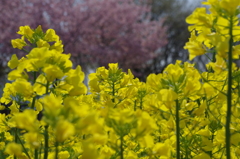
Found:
[0,0,240,159]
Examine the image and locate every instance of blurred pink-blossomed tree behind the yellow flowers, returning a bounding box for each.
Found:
[0,0,167,76]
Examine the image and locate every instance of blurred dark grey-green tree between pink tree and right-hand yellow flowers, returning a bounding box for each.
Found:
[137,0,201,78]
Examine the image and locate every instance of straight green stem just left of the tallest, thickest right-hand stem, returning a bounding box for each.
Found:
[176,100,180,159]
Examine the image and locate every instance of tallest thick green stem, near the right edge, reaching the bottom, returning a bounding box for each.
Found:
[225,17,233,159]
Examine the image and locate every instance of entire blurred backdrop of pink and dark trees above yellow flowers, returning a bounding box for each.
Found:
[0,0,204,95]
